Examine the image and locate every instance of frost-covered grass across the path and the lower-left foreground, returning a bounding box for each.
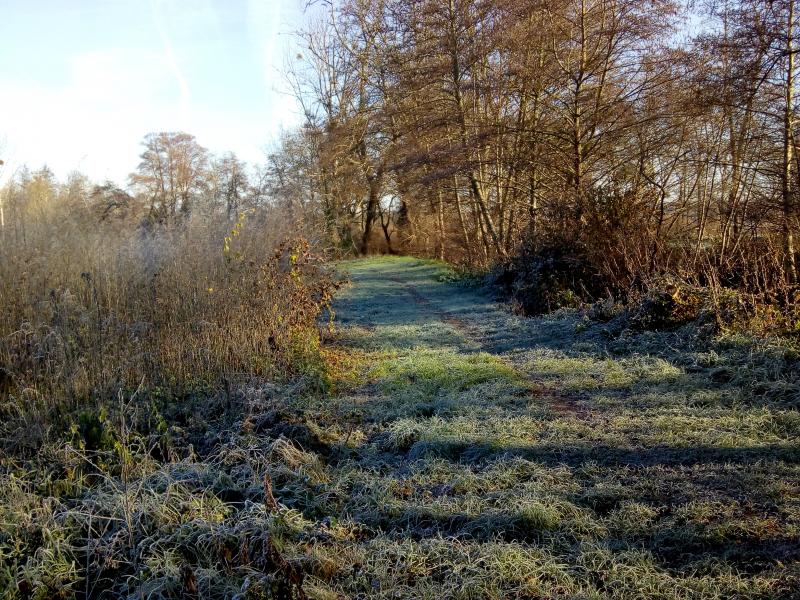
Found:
[6,258,800,600]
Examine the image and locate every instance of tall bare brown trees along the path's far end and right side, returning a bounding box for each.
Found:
[270,0,800,300]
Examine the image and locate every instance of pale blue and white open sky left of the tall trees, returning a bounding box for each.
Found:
[0,0,303,183]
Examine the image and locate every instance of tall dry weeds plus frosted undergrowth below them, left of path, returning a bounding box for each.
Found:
[0,197,335,599]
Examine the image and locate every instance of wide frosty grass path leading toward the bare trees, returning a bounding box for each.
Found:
[292,258,800,598]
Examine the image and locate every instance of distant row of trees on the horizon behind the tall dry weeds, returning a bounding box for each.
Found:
[0,132,316,243]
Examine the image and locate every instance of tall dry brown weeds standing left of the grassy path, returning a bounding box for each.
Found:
[0,206,331,450]
